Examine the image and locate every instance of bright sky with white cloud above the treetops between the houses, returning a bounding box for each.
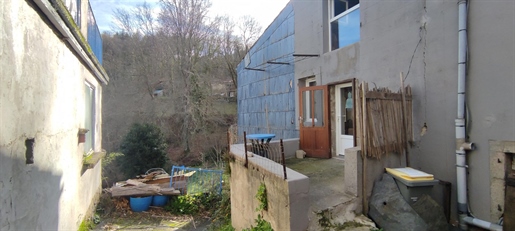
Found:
[90,0,289,32]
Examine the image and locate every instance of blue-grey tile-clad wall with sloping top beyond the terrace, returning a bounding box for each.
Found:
[237,4,299,139]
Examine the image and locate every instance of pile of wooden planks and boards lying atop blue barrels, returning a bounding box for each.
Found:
[111,172,183,197]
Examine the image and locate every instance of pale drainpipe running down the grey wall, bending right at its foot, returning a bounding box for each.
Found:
[455,0,502,230]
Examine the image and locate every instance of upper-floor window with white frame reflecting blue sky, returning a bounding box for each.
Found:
[329,0,360,50]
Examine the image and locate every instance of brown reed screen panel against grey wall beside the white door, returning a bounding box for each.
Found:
[355,82,413,159]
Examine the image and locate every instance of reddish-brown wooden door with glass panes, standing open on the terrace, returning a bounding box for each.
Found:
[299,85,331,158]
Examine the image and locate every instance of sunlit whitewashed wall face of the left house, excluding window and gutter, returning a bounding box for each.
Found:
[0,1,102,230]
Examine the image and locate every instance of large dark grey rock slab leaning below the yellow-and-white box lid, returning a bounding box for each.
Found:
[368,173,428,231]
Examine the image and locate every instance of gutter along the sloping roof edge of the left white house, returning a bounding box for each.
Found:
[33,0,109,85]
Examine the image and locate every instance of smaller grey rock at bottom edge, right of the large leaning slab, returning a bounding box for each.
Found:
[411,195,447,231]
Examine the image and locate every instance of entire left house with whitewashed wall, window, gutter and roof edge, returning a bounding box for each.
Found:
[0,0,109,230]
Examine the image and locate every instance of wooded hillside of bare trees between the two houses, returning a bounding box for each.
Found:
[103,0,261,162]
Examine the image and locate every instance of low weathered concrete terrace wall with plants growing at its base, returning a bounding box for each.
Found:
[230,144,310,230]
